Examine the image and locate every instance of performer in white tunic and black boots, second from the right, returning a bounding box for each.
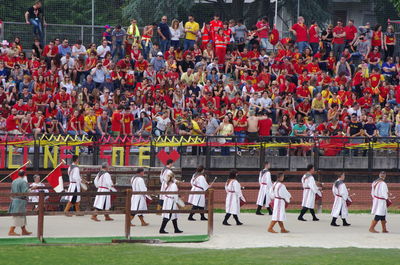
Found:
[331,173,351,226]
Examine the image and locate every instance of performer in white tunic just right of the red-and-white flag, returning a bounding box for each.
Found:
[64,155,82,216]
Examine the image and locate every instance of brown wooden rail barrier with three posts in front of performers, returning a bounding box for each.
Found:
[0,189,214,242]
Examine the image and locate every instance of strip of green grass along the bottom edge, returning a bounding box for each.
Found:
[0,244,400,265]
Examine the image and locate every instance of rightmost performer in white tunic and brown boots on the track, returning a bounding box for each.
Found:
[369,171,389,233]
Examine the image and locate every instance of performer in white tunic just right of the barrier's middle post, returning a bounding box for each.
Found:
[131,168,151,226]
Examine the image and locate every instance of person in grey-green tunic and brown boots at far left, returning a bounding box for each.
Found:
[8,170,32,236]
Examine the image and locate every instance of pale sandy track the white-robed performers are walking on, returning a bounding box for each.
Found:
[0,214,400,249]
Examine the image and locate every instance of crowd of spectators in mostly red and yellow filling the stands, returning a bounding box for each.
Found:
[0,14,400,156]
